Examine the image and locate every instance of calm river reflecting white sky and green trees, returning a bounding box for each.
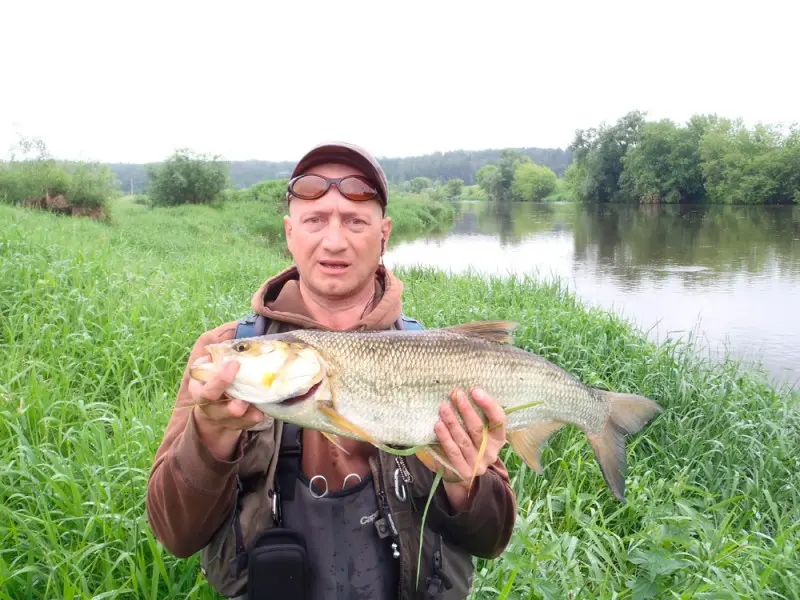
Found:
[385,202,800,389]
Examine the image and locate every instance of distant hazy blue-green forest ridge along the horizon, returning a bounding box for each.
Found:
[108,148,572,194]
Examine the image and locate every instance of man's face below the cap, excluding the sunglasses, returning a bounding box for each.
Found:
[284,163,392,298]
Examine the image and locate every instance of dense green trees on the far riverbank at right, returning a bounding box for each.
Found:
[566,111,800,204]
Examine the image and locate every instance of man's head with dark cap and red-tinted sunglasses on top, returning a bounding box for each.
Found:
[284,144,392,298]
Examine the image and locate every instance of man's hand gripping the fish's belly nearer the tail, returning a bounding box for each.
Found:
[434,389,506,511]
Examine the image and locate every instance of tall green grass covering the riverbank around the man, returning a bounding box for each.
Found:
[0,202,800,600]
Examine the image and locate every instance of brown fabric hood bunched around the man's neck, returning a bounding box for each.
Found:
[252,265,403,331]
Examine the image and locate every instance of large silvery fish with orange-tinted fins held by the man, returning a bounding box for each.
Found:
[190,321,661,501]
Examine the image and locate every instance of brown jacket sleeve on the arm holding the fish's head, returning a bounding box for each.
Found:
[146,322,242,558]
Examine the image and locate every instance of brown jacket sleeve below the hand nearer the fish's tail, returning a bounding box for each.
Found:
[407,457,517,558]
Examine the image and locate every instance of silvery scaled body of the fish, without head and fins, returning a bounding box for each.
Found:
[293,330,609,445]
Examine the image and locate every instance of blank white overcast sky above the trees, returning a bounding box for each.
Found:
[0,0,800,162]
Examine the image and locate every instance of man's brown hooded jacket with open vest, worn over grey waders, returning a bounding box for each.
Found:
[146,267,517,600]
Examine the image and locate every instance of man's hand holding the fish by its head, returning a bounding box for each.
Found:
[187,330,264,460]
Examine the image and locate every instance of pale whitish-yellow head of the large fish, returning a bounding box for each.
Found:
[189,338,325,405]
